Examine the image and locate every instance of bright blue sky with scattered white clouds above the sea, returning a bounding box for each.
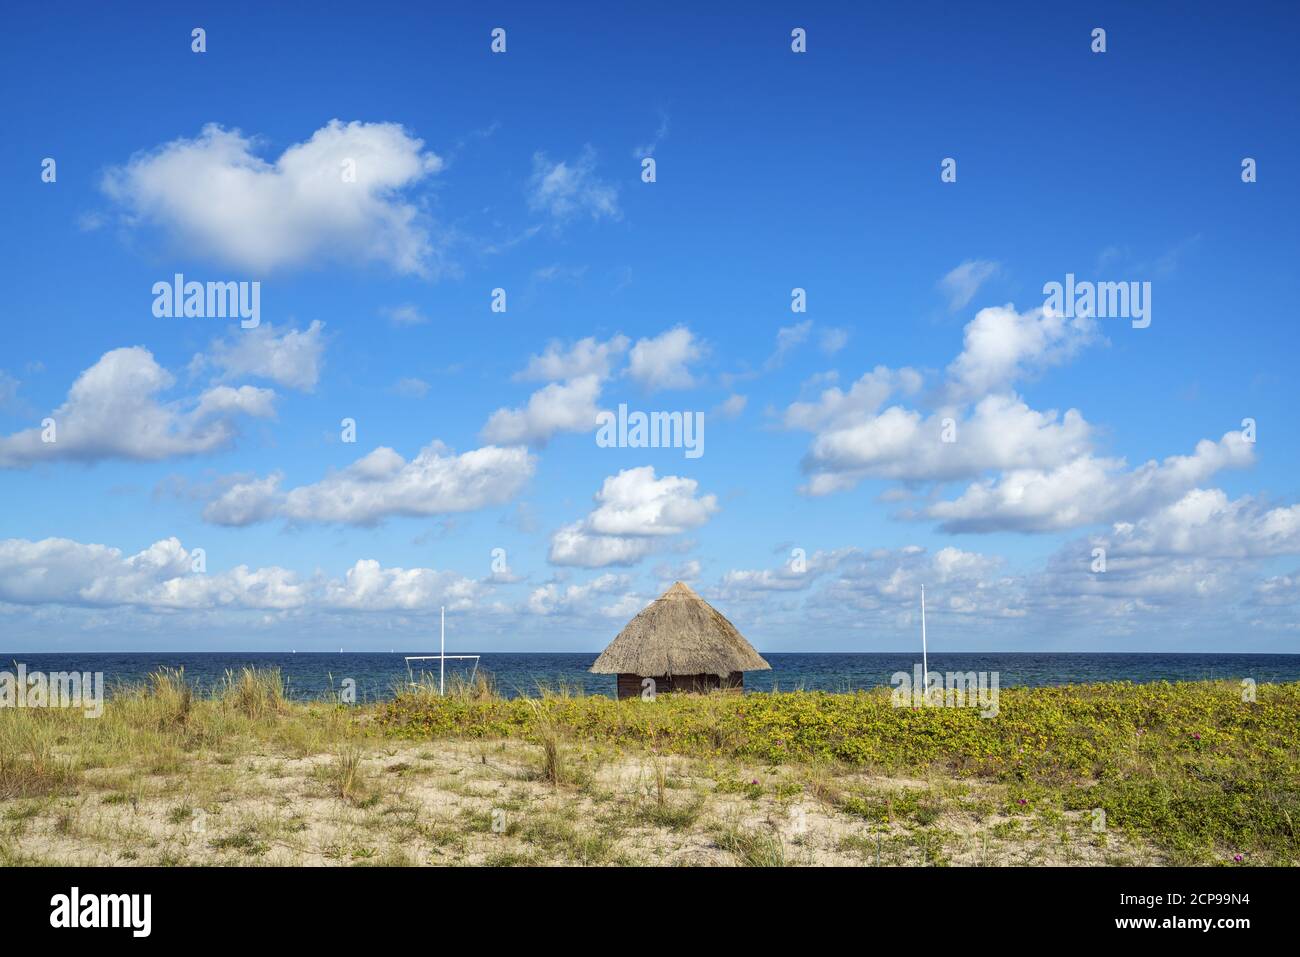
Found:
[0,3,1300,651]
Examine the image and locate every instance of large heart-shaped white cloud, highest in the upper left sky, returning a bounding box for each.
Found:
[103,120,442,274]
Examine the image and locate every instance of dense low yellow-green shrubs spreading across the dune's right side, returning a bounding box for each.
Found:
[377,681,1300,863]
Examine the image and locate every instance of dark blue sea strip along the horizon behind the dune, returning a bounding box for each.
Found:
[0,651,1300,701]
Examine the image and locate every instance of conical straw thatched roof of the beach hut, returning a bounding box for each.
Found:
[592,581,772,676]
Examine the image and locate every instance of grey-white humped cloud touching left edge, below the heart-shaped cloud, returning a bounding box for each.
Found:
[0,346,276,468]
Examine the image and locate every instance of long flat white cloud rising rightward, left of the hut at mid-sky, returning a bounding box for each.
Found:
[203,442,536,525]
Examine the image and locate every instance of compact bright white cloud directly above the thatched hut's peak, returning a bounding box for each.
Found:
[550,465,718,568]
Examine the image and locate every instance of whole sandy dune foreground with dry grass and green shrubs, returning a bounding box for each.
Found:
[0,670,1300,866]
